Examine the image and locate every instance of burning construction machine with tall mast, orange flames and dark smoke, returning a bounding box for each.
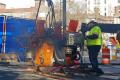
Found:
[33,0,88,75]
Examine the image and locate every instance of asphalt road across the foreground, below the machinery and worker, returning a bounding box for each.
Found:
[0,65,120,80]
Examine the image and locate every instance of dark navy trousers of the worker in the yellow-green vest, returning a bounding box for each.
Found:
[87,45,101,72]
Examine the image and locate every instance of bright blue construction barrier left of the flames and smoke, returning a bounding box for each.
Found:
[0,16,35,61]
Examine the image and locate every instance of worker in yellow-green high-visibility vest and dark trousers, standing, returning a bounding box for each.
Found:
[86,21,103,75]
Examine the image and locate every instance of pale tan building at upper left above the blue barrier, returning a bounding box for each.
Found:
[0,0,47,19]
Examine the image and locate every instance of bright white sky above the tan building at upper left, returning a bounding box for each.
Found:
[0,0,35,8]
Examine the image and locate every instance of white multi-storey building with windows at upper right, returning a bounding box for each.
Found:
[87,0,120,16]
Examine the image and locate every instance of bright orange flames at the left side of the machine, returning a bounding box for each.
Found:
[35,42,54,66]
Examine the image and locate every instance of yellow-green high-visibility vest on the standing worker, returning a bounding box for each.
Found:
[87,26,102,46]
